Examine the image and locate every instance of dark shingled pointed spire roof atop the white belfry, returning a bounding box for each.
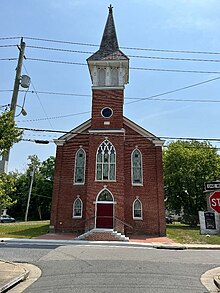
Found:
[87,5,128,61]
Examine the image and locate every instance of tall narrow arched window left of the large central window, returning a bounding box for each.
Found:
[74,148,86,184]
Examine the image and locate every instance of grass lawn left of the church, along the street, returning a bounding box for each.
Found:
[0,221,49,238]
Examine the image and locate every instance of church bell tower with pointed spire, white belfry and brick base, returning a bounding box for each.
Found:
[87,5,129,130]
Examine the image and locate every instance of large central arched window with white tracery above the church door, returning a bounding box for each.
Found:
[96,140,116,180]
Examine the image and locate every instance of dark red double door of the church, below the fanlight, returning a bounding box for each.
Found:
[96,203,113,229]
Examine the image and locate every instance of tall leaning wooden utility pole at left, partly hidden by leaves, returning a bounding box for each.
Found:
[0,38,25,173]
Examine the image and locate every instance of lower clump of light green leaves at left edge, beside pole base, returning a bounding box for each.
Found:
[0,173,16,214]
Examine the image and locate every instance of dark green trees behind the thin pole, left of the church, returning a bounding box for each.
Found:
[10,155,55,220]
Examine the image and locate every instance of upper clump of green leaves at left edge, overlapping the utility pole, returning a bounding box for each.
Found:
[0,112,22,155]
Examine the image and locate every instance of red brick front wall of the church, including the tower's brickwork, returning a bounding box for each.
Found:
[51,90,165,236]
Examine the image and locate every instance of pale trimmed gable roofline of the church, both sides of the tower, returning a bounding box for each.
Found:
[54,117,164,146]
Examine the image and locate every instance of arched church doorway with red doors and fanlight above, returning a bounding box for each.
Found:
[96,189,114,229]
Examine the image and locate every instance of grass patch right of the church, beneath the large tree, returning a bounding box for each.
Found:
[167,223,220,245]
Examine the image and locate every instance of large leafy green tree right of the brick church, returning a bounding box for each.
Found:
[163,141,220,226]
